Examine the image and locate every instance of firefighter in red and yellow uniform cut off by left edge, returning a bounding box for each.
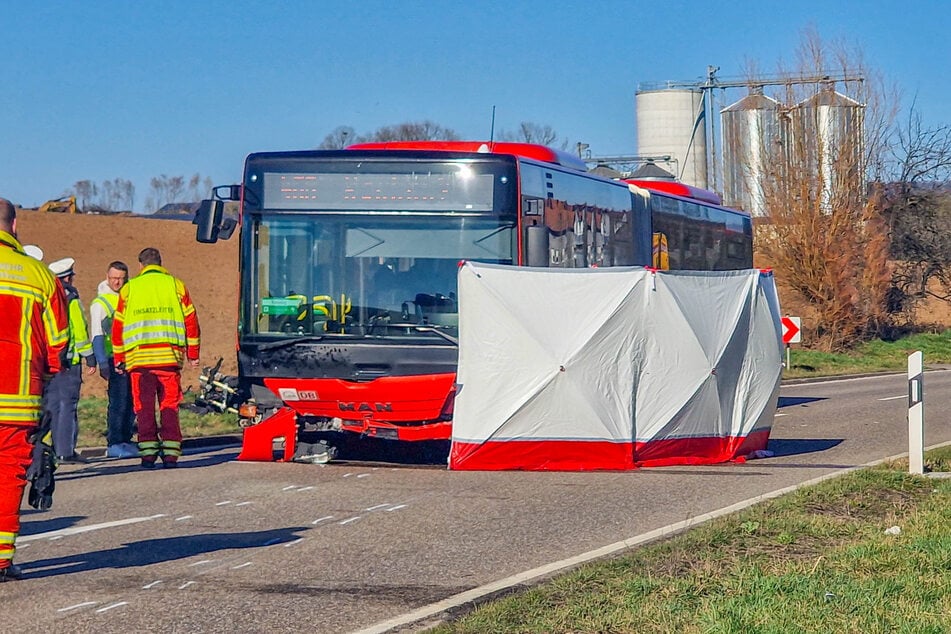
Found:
[0,198,67,582]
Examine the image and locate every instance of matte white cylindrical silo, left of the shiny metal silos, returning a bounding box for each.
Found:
[634,87,707,189]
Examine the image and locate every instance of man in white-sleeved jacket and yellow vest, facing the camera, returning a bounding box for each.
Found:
[89,260,139,458]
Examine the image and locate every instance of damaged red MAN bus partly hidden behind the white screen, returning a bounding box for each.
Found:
[196,141,752,459]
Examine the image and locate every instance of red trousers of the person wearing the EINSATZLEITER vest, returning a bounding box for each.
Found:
[129,368,183,462]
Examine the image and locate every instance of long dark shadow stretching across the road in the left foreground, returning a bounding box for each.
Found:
[21,526,307,579]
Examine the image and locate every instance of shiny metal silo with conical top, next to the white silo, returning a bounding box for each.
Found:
[720,90,782,216]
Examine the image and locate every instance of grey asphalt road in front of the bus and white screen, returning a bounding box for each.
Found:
[7,372,951,633]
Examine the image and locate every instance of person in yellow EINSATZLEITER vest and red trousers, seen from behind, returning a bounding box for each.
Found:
[112,247,201,469]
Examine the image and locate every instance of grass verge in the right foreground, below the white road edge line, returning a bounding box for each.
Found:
[432,448,951,634]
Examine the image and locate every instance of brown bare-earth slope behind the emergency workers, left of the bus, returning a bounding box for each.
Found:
[17,211,238,396]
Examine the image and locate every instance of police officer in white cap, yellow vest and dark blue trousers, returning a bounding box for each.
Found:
[43,258,96,463]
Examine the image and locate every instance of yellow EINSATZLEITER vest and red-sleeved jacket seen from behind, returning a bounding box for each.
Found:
[112,264,201,370]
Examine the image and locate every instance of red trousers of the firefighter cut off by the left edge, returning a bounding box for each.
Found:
[0,421,33,569]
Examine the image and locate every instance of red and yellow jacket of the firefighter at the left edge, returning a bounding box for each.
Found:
[0,231,68,425]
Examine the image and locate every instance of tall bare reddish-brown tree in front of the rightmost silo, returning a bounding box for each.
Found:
[749,30,897,350]
